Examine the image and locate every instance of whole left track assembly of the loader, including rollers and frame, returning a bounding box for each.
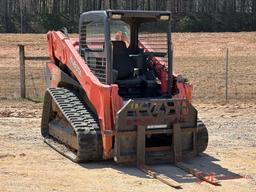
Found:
[41,88,102,162]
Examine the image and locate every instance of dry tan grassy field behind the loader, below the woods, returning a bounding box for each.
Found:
[0,32,256,100]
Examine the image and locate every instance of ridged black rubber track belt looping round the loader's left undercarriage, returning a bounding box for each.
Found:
[42,88,102,162]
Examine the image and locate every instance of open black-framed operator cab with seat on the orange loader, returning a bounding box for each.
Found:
[80,11,171,98]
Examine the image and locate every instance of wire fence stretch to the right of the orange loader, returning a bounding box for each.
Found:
[174,47,256,100]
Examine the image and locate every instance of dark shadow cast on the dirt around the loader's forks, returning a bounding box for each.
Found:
[80,154,242,183]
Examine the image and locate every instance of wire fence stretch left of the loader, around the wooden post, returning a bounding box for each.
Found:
[0,44,47,100]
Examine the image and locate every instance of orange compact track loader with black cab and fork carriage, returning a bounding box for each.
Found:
[41,10,208,165]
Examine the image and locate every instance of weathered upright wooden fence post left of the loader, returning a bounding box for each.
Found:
[18,45,26,99]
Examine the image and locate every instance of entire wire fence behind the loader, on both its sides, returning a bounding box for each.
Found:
[0,44,256,100]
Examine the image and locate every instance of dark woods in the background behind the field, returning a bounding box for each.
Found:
[0,0,256,33]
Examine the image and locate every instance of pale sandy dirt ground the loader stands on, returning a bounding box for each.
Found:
[0,100,256,192]
